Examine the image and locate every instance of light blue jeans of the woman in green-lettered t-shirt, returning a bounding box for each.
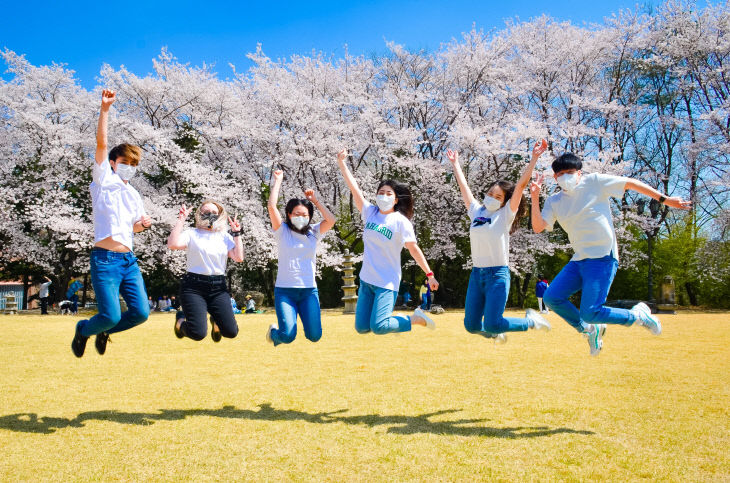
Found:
[355,280,411,334]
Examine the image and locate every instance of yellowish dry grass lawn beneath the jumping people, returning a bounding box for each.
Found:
[0,312,730,481]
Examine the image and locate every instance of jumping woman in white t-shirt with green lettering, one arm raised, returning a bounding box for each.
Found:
[337,149,439,334]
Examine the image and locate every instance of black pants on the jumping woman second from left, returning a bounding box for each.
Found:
[178,272,238,340]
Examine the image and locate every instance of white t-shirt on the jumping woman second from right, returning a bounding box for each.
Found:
[469,201,516,267]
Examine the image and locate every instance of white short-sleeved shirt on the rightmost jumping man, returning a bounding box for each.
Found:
[542,173,629,260]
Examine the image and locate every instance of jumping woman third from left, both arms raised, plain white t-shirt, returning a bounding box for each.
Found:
[266,170,336,346]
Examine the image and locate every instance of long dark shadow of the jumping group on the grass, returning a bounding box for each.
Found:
[0,403,594,439]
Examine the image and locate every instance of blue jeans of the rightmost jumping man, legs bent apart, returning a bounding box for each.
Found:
[542,255,636,332]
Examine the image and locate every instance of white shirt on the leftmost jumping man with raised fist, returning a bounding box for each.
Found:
[89,159,145,250]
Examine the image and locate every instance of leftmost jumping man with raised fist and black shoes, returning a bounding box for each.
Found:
[71,89,152,357]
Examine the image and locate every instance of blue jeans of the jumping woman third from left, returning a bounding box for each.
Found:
[271,287,322,345]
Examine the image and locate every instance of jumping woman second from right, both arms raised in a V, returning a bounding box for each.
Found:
[446,139,550,343]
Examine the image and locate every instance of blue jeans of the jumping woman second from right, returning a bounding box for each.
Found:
[464,266,528,337]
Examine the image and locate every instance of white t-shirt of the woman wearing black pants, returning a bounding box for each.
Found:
[180,228,236,275]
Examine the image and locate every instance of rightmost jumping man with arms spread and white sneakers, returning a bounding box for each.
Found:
[530,153,691,356]
